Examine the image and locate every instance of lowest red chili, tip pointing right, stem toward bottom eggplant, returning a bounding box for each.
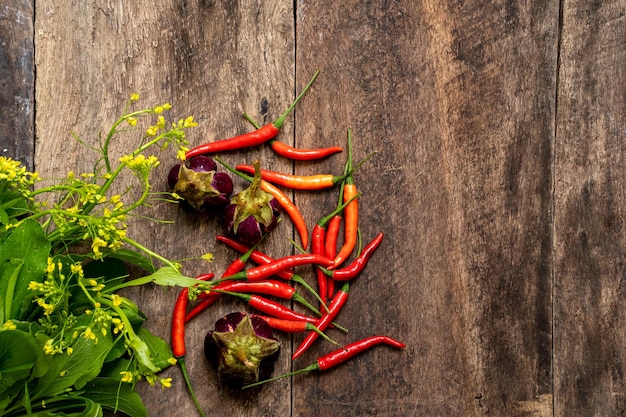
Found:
[243,336,406,388]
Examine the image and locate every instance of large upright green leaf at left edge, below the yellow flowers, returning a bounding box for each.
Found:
[0,219,50,321]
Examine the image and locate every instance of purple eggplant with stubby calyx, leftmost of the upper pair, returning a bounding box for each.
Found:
[167,156,233,211]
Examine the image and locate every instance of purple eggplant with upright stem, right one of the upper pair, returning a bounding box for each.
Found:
[224,160,280,245]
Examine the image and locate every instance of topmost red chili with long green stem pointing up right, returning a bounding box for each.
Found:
[186,71,319,159]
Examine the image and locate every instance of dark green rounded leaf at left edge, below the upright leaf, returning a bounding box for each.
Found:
[0,330,40,394]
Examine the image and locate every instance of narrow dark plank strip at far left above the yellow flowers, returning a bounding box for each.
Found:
[0,0,35,170]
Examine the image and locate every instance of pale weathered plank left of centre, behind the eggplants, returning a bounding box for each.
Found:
[36,0,295,416]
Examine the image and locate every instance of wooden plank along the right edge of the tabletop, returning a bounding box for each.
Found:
[554,1,626,416]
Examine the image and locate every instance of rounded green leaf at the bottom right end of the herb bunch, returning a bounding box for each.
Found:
[83,377,148,417]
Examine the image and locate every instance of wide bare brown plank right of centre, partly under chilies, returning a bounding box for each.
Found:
[293,1,559,416]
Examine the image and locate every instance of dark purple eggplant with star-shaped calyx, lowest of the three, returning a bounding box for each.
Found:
[204,313,280,388]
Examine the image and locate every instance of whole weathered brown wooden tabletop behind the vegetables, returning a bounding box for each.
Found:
[0,0,626,416]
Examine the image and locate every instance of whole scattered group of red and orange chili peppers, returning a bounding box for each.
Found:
[172,73,405,410]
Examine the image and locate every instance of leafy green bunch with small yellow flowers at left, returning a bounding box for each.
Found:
[0,94,205,417]
